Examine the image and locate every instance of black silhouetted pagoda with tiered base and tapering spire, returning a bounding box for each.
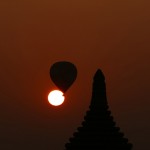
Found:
[65,69,132,150]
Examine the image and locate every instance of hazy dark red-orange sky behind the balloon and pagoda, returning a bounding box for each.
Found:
[0,0,150,150]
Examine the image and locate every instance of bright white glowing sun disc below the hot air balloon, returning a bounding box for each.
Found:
[48,90,65,106]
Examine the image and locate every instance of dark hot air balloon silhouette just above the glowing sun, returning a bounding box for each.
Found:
[50,61,77,93]
